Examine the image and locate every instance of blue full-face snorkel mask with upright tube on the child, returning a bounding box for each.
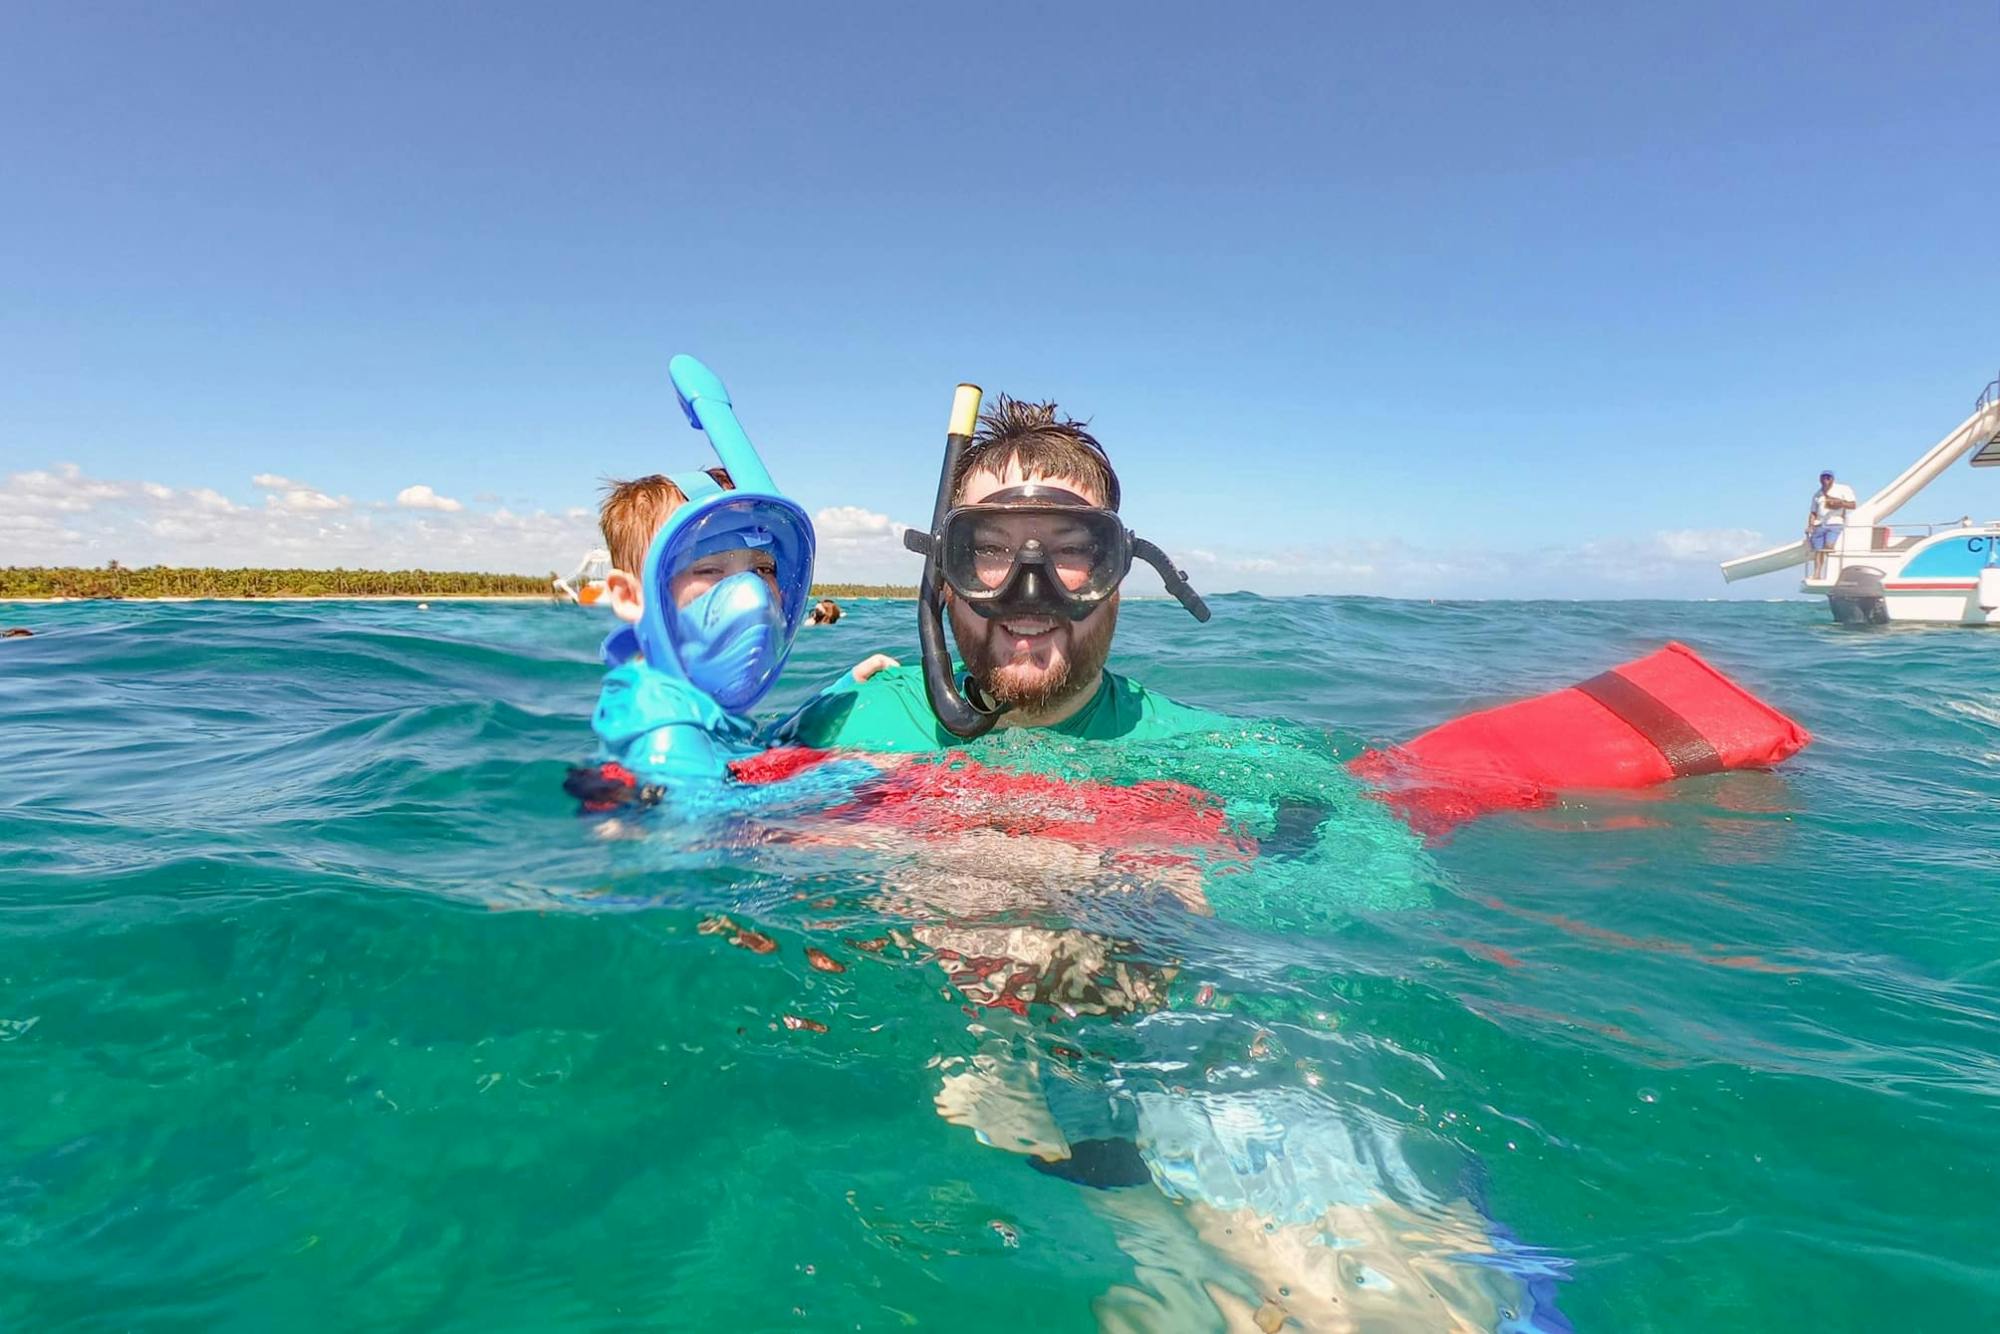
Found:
[606,356,814,712]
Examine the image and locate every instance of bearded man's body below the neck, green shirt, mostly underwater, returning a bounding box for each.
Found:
[752,670,1568,1330]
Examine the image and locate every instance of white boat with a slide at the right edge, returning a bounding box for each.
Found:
[1722,378,2000,626]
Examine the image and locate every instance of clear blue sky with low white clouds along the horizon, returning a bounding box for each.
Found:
[0,0,2000,596]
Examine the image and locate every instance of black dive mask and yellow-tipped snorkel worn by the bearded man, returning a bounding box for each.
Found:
[902,384,1208,738]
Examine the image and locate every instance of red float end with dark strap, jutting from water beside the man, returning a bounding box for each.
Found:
[1348,644,1812,832]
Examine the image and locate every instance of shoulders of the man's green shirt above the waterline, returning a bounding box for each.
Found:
[782,666,1242,754]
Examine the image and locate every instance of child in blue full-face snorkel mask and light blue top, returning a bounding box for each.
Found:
[570,356,892,808]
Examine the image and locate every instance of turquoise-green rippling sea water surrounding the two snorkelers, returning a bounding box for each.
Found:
[0,596,2000,1330]
